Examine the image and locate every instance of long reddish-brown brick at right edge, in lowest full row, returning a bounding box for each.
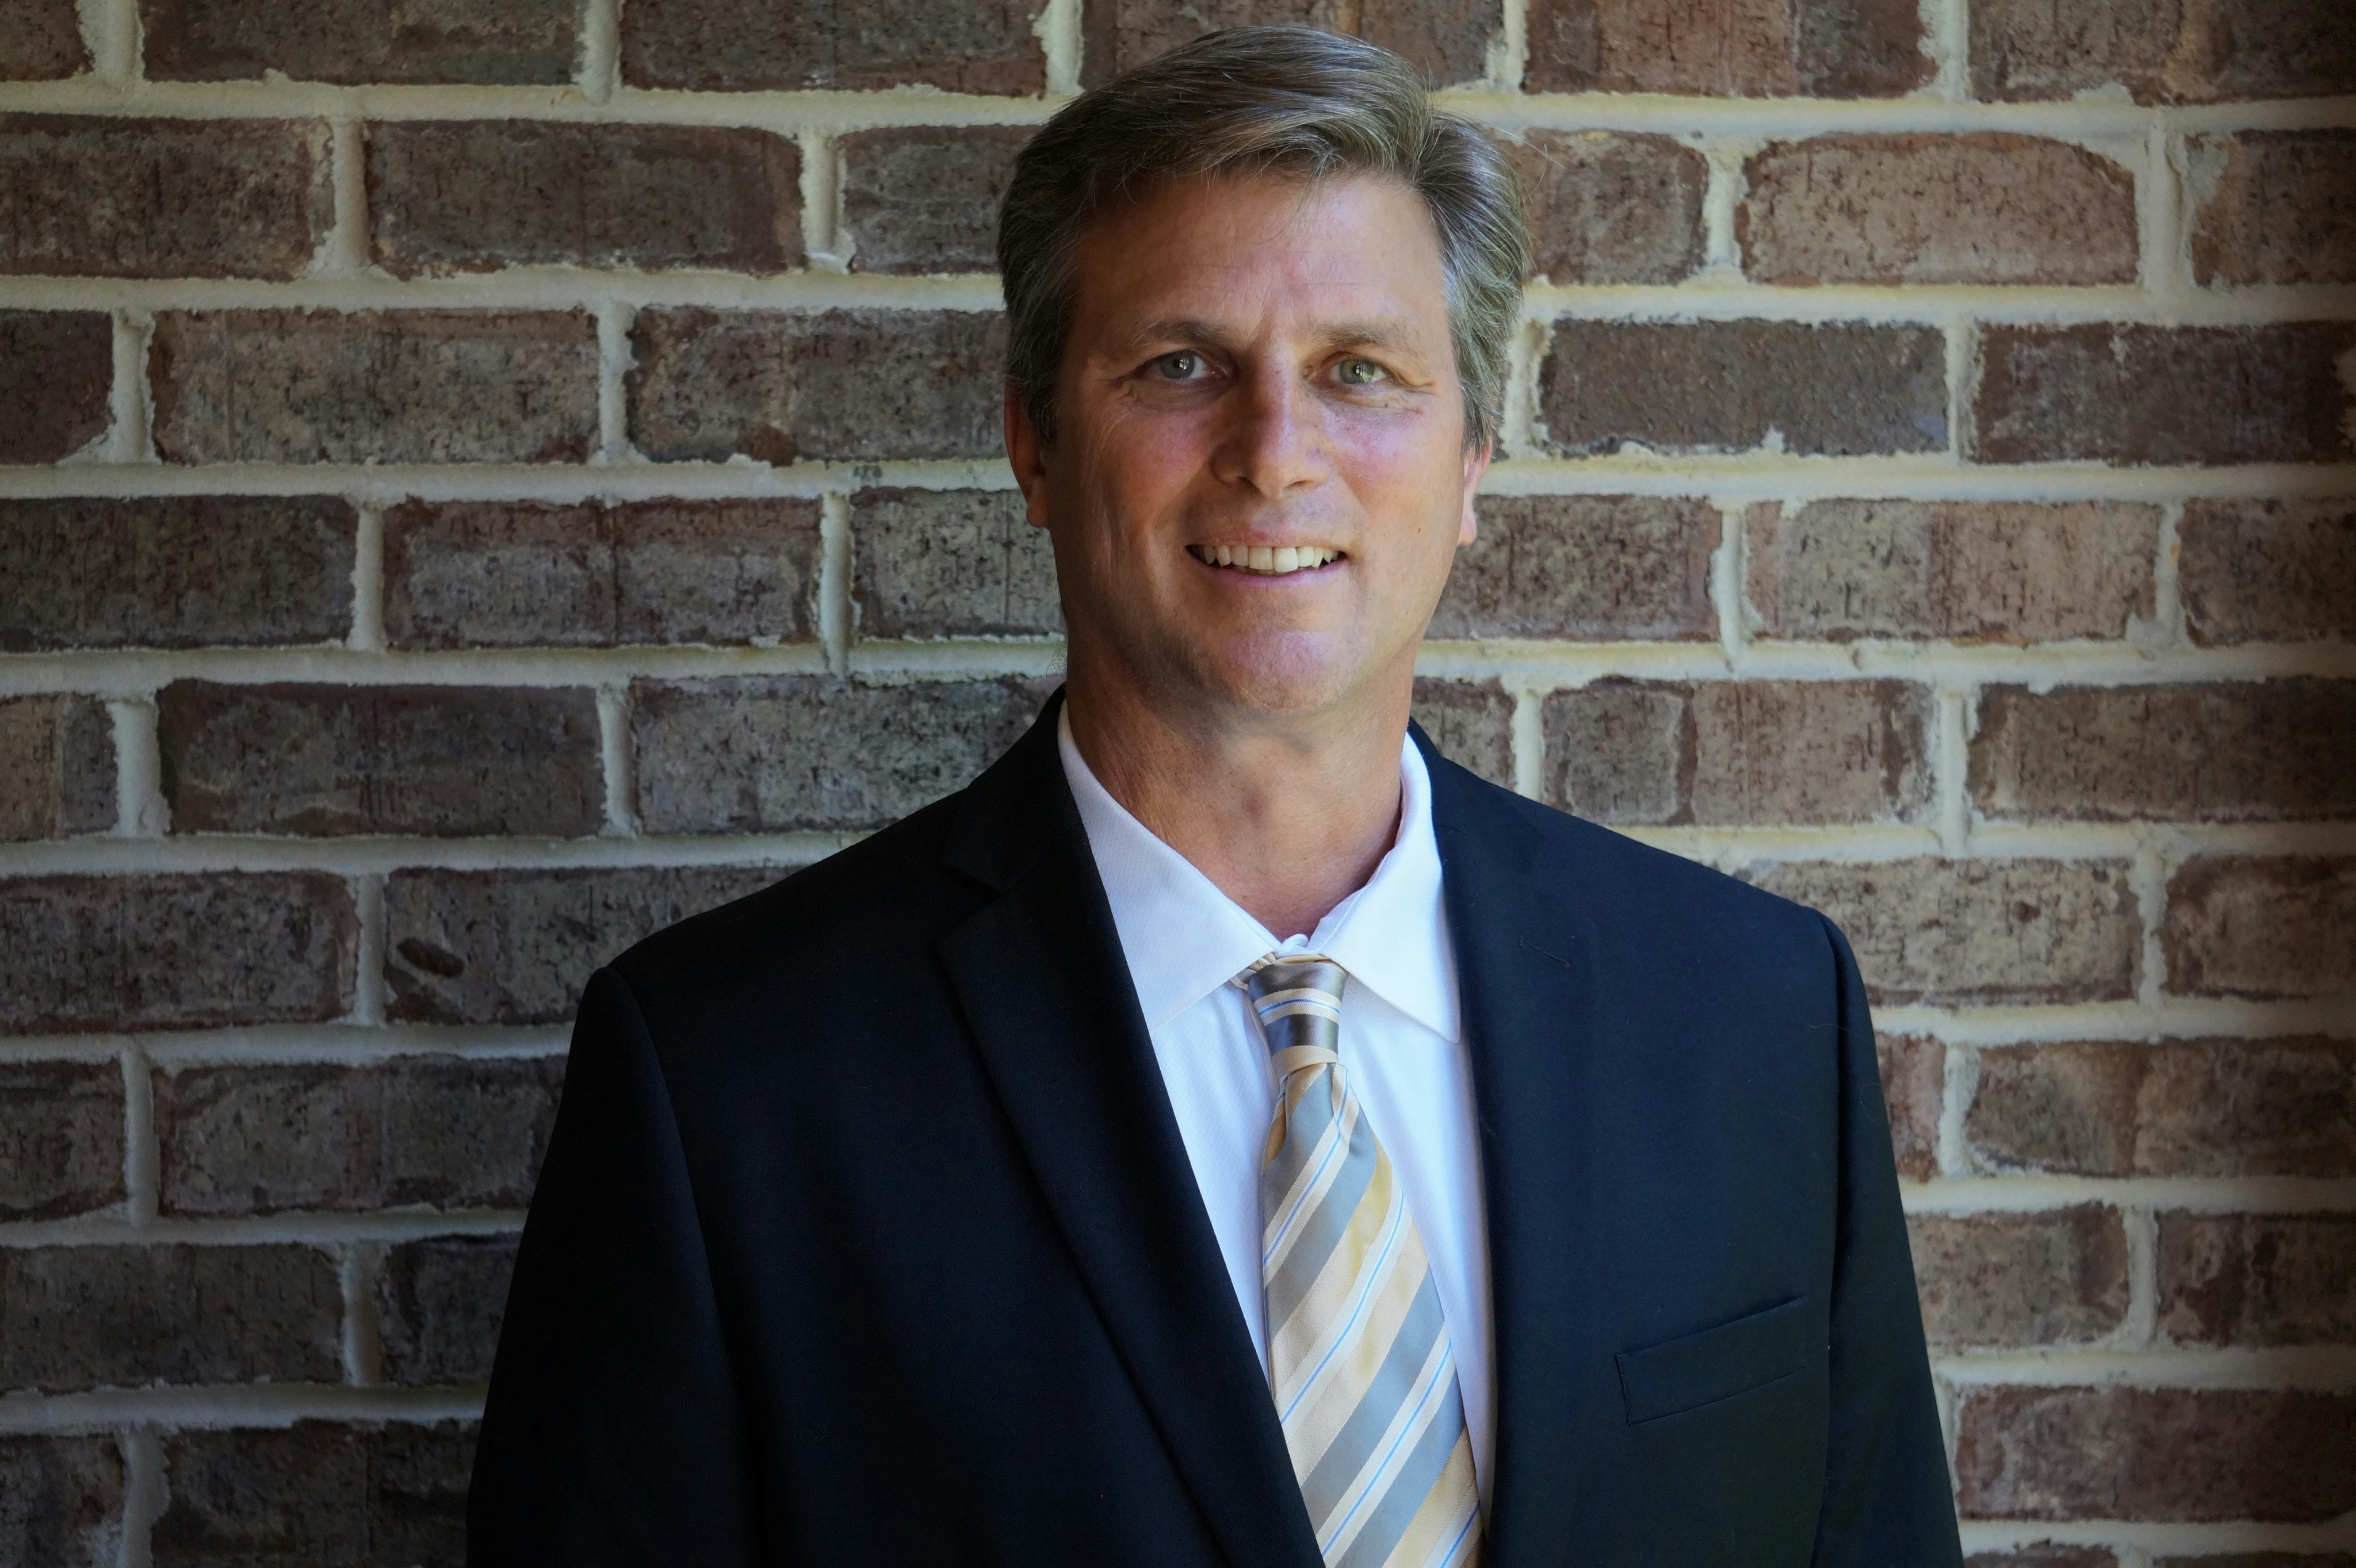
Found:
[1956,1385,2356,1521]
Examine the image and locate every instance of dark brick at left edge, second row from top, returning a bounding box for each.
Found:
[0,116,335,278]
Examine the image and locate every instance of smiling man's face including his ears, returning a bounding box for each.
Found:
[1008,177,1487,713]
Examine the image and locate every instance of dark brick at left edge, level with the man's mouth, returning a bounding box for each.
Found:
[0,495,358,652]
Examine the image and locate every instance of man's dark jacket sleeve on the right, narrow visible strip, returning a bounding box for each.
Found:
[1814,920,1963,1568]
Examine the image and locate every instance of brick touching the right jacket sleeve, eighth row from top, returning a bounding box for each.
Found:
[1906,1203,2128,1347]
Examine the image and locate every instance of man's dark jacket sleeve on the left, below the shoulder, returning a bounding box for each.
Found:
[466,970,752,1568]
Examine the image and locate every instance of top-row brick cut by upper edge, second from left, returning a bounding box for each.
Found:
[139,0,580,87]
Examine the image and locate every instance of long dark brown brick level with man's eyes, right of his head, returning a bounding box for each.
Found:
[1539,320,1946,457]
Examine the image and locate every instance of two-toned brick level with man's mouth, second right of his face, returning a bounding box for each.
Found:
[1743,502,2160,643]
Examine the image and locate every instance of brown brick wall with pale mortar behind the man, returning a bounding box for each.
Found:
[0,0,2356,1568]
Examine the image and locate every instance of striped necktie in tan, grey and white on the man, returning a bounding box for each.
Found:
[1244,954,1479,1568]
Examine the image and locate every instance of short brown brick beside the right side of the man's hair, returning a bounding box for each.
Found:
[1505,129,1711,282]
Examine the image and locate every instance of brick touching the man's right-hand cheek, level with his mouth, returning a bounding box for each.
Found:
[1425,495,1724,643]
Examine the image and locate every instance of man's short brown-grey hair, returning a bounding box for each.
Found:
[999,26,1529,448]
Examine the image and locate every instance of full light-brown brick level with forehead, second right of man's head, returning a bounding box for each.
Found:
[1734,132,2137,285]
